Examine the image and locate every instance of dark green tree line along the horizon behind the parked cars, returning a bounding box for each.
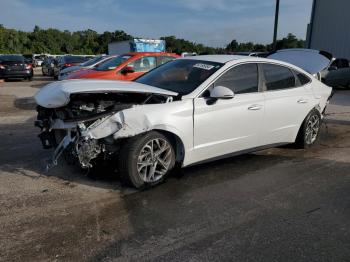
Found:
[0,24,305,55]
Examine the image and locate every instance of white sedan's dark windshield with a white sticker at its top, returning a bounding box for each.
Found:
[135,59,224,95]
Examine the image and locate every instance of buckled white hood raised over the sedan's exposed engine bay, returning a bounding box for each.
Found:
[34,80,177,108]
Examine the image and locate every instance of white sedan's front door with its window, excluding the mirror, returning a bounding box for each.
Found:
[193,63,265,162]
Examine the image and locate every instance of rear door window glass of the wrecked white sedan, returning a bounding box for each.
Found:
[262,64,296,91]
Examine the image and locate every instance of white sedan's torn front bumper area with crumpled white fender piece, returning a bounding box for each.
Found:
[35,110,150,170]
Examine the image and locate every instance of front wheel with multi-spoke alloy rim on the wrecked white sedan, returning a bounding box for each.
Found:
[118,131,175,189]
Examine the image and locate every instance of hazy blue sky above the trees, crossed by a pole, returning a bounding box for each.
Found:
[0,0,312,47]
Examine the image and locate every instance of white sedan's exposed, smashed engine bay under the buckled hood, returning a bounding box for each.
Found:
[35,93,173,168]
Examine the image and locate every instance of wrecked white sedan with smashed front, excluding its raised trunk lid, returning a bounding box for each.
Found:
[35,55,332,188]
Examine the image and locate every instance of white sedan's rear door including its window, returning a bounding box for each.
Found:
[259,63,313,144]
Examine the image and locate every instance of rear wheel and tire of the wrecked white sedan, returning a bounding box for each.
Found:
[295,109,322,149]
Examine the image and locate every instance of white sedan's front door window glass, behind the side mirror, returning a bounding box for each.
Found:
[214,64,259,94]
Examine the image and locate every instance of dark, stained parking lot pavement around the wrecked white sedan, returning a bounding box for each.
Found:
[0,70,350,262]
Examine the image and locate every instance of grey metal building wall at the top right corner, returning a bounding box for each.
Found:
[306,0,350,59]
